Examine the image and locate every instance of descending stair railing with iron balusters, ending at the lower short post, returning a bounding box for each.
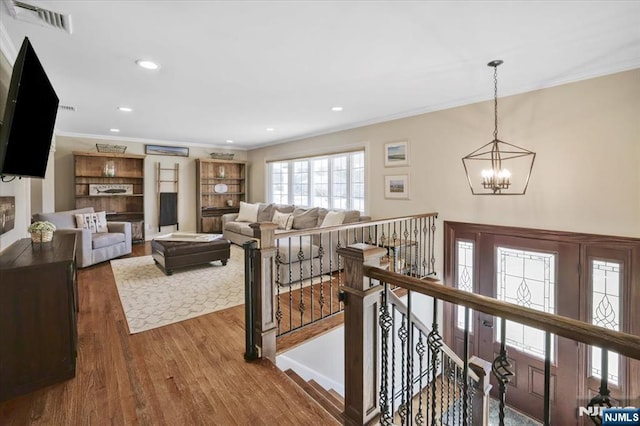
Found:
[379,284,491,425]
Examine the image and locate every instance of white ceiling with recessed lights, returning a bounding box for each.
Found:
[0,0,640,149]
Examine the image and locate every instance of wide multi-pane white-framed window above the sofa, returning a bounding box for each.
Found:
[268,150,365,213]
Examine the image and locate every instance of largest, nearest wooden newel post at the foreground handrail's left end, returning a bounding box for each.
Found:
[338,244,386,425]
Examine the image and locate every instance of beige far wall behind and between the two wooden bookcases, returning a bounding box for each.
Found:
[55,136,247,239]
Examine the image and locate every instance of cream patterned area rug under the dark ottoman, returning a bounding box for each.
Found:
[111,244,244,334]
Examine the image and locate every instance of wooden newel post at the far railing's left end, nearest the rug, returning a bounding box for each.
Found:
[249,222,277,364]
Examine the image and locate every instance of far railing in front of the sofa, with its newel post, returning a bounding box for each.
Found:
[242,213,437,359]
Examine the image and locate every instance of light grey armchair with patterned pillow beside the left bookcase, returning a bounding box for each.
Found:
[32,207,131,268]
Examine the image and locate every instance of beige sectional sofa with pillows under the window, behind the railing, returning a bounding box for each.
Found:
[222,203,371,285]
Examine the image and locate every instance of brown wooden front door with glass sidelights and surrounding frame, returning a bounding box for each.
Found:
[443,222,640,425]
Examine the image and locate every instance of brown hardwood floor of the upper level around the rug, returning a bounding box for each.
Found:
[0,243,338,426]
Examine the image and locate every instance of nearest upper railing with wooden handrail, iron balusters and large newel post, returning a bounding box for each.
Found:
[339,244,640,425]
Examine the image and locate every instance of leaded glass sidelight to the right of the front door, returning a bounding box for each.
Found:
[591,260,622,385]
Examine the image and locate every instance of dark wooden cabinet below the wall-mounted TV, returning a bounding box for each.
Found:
[0,233,78,401]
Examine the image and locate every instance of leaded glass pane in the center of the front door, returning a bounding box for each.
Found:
[496,247,556,362]
